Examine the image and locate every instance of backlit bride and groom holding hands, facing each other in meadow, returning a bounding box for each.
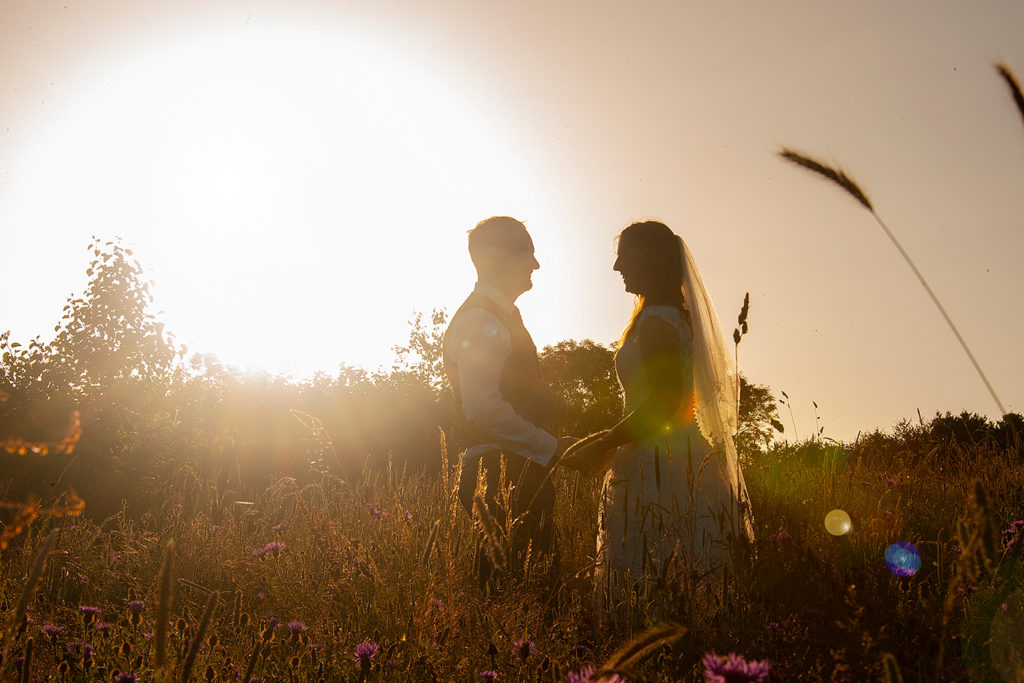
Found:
[444,216,753,611]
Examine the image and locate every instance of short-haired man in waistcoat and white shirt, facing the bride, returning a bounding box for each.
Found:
[443,216,572,588]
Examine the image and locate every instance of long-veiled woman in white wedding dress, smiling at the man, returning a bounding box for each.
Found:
[559,221,753,613]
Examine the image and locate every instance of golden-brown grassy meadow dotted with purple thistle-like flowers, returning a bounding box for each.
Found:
[0,409,1024,681]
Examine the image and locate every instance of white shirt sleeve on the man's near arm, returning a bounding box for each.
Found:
[449,308,558,467]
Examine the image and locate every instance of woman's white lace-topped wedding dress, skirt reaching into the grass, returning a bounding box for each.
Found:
[595,306,743,615]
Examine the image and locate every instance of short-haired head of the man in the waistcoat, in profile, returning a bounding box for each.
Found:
[469,216,541,300]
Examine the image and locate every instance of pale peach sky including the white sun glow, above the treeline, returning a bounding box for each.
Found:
[0,0,1024,440]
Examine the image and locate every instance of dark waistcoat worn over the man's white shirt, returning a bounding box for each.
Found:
[444,292,556,445]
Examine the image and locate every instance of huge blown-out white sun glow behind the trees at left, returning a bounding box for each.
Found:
[2,21,544,373]
